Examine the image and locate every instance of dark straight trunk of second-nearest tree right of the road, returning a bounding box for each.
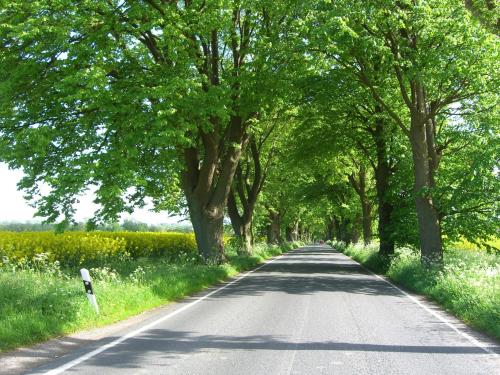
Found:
[373,118,394,256]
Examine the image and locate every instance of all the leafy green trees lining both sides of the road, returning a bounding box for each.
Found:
[0,0,500,265]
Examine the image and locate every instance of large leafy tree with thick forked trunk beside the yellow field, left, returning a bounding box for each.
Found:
[0,0,296,262]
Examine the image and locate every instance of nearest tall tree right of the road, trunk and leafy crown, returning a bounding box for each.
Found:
[310,0,496,265]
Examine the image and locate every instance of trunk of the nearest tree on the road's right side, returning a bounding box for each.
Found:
[410,92,443,266]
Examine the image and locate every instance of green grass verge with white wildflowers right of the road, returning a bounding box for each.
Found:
[333,244,500,340]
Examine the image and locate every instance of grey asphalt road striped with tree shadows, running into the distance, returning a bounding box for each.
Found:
[28,246,500,375]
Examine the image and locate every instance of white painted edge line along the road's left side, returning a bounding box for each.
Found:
[33,253,286,375]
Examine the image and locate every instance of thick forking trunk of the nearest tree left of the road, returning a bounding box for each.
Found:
[177,18,254,263]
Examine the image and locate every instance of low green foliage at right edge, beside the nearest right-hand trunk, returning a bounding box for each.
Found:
[436,126,500,247]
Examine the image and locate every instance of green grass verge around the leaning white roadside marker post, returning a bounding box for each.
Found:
[0,245,300,351]
